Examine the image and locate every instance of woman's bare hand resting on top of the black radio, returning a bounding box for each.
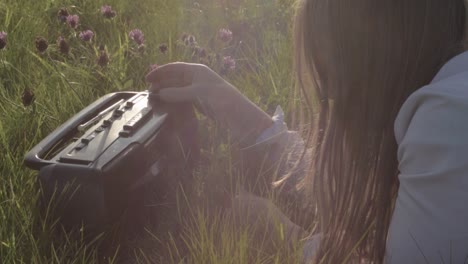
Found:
[146,62,273,145]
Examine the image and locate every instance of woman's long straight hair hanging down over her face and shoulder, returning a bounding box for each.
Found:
[295,0,465,263]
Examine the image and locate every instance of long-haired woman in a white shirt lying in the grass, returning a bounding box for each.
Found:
[147,0,468,263]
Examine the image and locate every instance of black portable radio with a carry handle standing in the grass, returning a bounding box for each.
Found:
[25,92,198,231]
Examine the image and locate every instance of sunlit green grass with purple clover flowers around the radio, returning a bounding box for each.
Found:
[0,0,308,263]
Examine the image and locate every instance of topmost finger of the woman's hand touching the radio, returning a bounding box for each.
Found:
[146,62,193,82]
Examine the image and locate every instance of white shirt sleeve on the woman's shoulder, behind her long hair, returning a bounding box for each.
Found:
[386,85,468,263]
